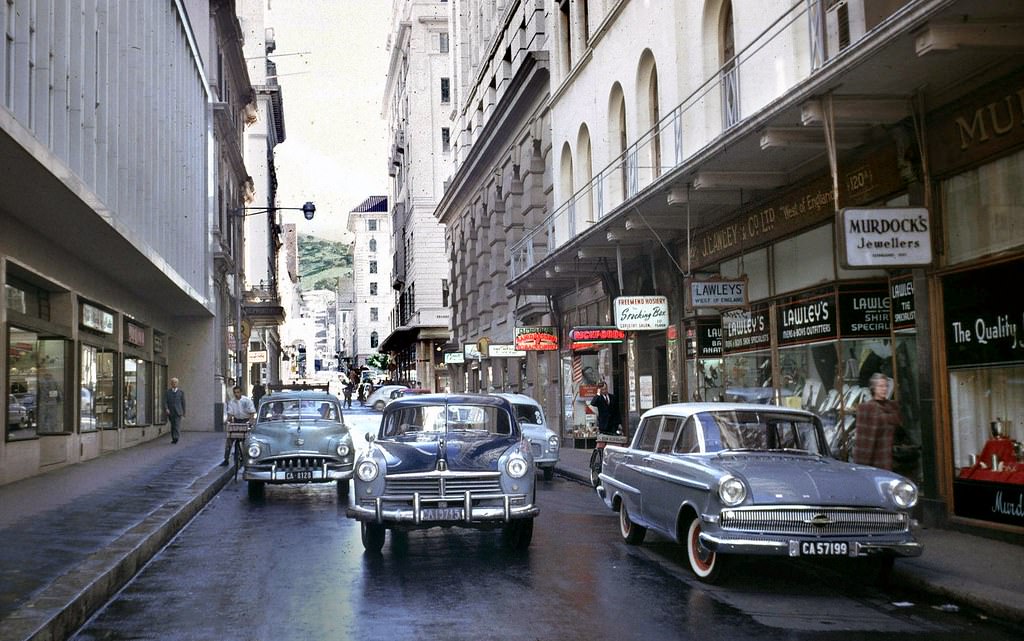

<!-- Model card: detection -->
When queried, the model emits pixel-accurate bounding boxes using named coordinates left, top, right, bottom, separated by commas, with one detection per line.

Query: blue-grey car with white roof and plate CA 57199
left=597, top=402, right=922, bottom=583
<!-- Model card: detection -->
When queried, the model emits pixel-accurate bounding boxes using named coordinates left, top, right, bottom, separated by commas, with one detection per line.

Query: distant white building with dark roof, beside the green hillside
left=348, top=196, right=394, bottom=367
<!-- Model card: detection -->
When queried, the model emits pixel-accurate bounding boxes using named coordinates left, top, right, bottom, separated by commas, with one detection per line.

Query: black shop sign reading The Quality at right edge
left=942, top=261, right=1024, bottom=368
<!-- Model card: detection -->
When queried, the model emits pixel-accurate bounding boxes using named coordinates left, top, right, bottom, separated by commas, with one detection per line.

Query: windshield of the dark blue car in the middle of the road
left=382, top=404, right=512, bottom=437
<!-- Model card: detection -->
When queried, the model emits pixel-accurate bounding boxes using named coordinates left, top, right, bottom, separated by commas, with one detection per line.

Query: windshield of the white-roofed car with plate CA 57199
left=694, top=412, right=827, bottom=454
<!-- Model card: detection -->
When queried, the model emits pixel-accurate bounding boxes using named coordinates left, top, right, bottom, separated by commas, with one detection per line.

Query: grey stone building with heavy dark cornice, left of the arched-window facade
left=436, top=0, right=561, bottom=399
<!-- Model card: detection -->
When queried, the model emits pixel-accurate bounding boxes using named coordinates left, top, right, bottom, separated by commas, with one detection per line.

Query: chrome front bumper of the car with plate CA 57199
left=700, top=531, right=924, bottom=557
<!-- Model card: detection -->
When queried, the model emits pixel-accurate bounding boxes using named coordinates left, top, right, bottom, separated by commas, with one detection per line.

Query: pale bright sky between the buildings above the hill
left=266, top=0, right=391, bottom=241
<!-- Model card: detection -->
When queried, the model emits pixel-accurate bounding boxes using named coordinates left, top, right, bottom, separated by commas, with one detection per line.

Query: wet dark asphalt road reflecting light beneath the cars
left=74, top=412, right=1020, bottom=641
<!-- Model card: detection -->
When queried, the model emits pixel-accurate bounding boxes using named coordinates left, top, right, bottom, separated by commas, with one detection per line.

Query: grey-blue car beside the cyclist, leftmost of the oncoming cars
left=242, top=391, right=355, bottom=500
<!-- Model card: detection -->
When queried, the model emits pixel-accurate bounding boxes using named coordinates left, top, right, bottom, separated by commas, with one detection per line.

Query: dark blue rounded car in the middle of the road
left=347, top=394, right=540, bottom=553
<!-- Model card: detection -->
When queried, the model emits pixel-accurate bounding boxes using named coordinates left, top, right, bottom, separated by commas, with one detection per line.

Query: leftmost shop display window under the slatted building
left=7, top=327, right=69, bottom=440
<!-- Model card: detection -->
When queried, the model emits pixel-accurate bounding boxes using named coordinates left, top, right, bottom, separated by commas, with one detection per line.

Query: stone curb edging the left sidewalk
left=3, top=466, right=233, bottom=641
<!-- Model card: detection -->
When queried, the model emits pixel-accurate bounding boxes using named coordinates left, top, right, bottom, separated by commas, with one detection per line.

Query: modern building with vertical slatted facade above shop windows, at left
left=0, top=0, right=249, bottom=482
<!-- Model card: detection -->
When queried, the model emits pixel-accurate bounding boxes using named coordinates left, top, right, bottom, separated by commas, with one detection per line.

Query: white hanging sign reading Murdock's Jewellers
left=836, top=207, right=932, bottom=268
